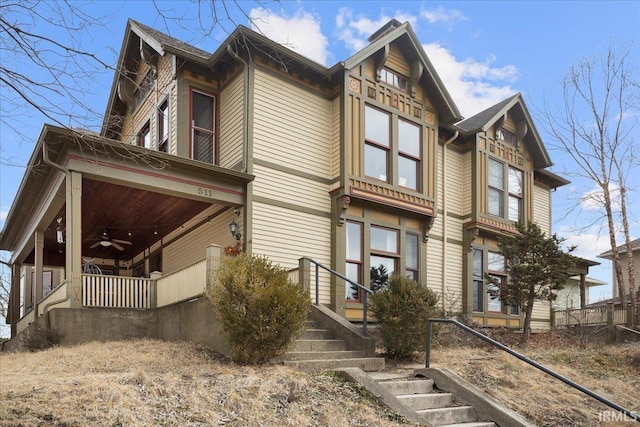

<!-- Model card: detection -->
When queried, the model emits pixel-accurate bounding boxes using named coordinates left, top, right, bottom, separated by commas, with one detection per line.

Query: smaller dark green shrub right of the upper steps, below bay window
left=371, top=275, right=438, bottom=359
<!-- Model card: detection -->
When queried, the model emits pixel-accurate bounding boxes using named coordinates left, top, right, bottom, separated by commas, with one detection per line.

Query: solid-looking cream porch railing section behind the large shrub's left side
left=156, top=260, right=207, bottom=307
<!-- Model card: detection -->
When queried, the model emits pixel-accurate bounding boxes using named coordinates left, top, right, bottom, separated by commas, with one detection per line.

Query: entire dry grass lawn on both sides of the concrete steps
left=0, top=336, right=640, bottom=427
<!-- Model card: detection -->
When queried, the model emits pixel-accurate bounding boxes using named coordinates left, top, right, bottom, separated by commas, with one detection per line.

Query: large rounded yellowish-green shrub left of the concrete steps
left=208, top=253, right=311, bottom=364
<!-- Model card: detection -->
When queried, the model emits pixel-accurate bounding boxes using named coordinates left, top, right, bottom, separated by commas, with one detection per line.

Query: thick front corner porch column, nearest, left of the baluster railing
left=65, top=171, right=82, bottom=308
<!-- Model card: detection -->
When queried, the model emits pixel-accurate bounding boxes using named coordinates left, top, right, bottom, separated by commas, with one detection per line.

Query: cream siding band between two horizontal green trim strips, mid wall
left=253, top=165, right=331, bottom=214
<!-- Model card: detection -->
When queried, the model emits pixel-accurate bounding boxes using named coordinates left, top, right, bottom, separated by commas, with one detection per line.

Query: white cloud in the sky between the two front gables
left=422, top=43, right=518, bottom=117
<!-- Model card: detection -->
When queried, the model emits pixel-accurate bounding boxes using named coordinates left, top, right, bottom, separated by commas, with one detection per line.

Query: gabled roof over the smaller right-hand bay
left=452, top=93, right=553, bottom=170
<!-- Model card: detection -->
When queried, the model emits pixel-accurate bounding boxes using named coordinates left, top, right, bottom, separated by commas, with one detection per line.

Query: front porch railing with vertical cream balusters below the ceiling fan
left=82, top=274, right=154, bottom=308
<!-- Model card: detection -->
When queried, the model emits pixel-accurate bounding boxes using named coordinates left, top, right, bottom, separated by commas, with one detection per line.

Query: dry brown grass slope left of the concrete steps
left=0, top=340, right=418, bottom=427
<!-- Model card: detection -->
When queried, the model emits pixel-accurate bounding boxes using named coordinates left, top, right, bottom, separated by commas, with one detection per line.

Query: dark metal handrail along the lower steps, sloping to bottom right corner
left=425, top=319, right=640, bottom=422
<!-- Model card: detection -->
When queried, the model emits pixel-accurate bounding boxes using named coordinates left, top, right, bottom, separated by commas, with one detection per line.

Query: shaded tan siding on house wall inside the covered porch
left=162, top=210, right=243, bottom=274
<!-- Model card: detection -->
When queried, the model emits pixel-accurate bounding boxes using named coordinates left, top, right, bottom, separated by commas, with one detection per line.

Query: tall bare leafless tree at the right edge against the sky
left=543, top=44, right=640, bottom=324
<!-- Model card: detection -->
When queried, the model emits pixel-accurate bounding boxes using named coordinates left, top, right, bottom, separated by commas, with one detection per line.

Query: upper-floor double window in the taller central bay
left=364, top=105, right=422, bottom=191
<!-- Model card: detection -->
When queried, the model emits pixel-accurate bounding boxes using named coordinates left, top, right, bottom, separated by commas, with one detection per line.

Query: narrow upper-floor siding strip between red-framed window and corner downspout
left=219, top=74, right=245, bottom=168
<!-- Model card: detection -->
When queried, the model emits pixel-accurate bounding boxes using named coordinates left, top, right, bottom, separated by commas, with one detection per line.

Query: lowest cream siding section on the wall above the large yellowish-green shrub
left=252, top=202, right=331, bottom=304
